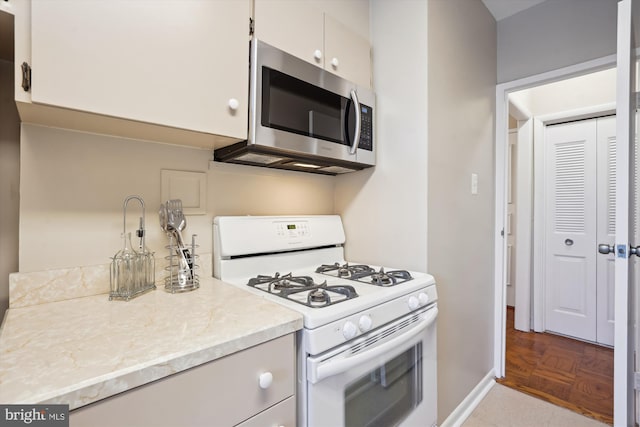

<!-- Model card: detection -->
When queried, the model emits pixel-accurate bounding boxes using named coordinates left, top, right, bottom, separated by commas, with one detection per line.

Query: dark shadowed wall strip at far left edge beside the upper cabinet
left=0, top=58, right=20, bottom=321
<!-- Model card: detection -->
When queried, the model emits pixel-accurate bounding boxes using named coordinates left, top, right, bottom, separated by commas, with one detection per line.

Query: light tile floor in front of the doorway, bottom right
left=462, top=384, right=607, bottom=427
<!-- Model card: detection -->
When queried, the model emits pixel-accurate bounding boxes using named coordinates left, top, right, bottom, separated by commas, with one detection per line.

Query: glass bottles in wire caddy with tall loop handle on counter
left=109, top=196, right=156, bottom=301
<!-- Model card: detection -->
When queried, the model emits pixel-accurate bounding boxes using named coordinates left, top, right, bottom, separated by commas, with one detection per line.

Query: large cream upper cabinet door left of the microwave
left=31, top=0, right=250, bottom=138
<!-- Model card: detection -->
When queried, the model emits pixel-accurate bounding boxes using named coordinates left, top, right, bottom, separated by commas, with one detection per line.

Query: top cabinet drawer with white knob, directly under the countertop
left=70, top=334, right=295, bottom=427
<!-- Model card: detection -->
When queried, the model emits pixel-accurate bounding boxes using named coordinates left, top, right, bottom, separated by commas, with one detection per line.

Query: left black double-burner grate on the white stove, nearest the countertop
left=247, top=273, right=358, bottom=308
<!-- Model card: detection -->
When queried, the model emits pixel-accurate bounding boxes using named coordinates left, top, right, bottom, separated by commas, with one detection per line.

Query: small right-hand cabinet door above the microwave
left=324, top=14, right=371, bottom=87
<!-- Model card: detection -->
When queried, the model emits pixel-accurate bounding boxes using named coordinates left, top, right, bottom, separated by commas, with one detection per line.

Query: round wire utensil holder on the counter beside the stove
left=164, top=234, right=200, bottom=294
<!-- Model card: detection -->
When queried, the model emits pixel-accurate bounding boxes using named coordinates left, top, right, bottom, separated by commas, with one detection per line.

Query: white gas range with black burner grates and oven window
left=213, top=215, right=438, bottom=427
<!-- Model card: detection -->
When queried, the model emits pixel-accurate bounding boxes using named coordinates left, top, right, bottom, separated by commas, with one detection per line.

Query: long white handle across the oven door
left=307, top=307, right=438, bottom=384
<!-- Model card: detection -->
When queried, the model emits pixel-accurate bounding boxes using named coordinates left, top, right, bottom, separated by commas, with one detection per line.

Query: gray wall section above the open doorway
left=498, top=0, right=618, bottom=83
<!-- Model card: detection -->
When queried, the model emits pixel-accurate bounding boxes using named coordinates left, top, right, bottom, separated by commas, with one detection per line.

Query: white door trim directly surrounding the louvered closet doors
left=530, top=102, right=616, bottom=332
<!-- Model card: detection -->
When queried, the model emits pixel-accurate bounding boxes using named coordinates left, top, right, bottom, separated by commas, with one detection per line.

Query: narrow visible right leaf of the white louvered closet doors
left=594, top=116, right=616, bottom=346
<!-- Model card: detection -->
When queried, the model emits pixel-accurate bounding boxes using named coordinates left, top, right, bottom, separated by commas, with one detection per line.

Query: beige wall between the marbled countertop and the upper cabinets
left=20, top=124, right=334, bottom=272
